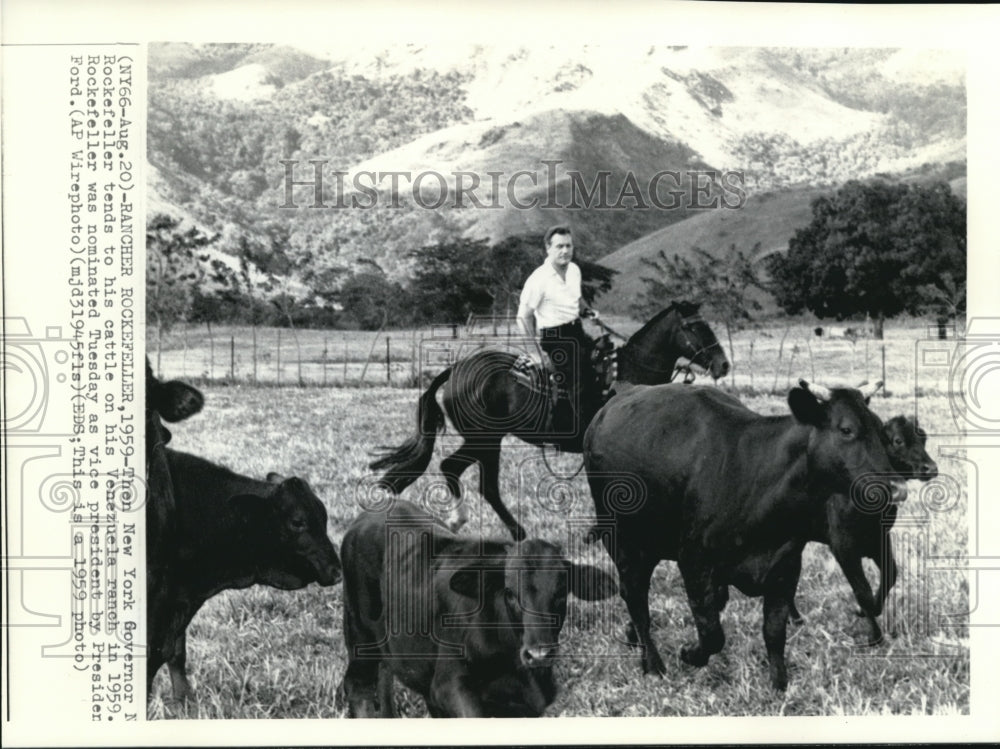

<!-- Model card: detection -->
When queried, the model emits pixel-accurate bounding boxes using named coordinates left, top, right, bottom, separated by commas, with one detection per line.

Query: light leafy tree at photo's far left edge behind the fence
left=146, top=213, right=217, bottom=370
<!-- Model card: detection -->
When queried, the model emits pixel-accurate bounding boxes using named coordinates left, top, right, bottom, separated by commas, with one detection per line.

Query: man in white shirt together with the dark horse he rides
left=369, top=227, right=729, bottom=540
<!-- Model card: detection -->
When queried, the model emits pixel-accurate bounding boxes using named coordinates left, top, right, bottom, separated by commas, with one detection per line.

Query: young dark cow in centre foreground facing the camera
left=338, top=500, right=616, bottom=717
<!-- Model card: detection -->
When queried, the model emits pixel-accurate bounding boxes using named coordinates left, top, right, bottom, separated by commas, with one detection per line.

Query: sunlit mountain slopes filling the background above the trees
left=148, top=44, right=965, bottom=296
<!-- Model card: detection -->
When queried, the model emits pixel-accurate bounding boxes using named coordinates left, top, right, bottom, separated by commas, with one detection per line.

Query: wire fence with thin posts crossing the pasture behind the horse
left=150, top=317, right=962, bottom=394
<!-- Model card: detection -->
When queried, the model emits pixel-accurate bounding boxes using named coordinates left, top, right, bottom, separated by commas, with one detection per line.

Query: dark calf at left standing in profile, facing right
left=146, top=449, right=340, bottom=700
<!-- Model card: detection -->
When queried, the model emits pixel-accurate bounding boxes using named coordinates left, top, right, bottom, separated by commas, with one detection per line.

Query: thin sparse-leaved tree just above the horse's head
left=632, top=242, right=765, bottom=368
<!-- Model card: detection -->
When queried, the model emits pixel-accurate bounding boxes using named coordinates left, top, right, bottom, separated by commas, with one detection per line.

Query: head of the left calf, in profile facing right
left=229, top=473, right=341, bottom=590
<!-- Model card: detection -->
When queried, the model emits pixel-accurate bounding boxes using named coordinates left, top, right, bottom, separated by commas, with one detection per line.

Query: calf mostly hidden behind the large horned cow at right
left=789, top=416, right=938, bottom=645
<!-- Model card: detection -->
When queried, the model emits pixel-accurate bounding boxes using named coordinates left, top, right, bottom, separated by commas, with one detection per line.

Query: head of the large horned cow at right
left=788, top=380, right=906, bottom=502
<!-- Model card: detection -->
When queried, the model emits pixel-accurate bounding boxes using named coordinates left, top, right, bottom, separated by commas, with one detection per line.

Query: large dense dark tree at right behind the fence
left=768, top=181, right=966, bottom=338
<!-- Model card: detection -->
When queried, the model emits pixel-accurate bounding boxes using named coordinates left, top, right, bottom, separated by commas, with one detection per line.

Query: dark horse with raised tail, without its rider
left=369, top=302, right=729, bottom=541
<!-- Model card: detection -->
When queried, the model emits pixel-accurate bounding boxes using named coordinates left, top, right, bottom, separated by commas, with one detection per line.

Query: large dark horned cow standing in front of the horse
left=584, top=383, right=905, bottom=689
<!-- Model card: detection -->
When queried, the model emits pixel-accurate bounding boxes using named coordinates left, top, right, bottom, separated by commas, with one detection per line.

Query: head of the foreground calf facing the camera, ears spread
left=450, top=539, right=618, bottom=667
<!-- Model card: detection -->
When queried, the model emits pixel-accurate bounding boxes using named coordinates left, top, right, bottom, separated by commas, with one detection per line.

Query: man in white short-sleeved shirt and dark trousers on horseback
left=517, top=226, right=598, bottom=440
